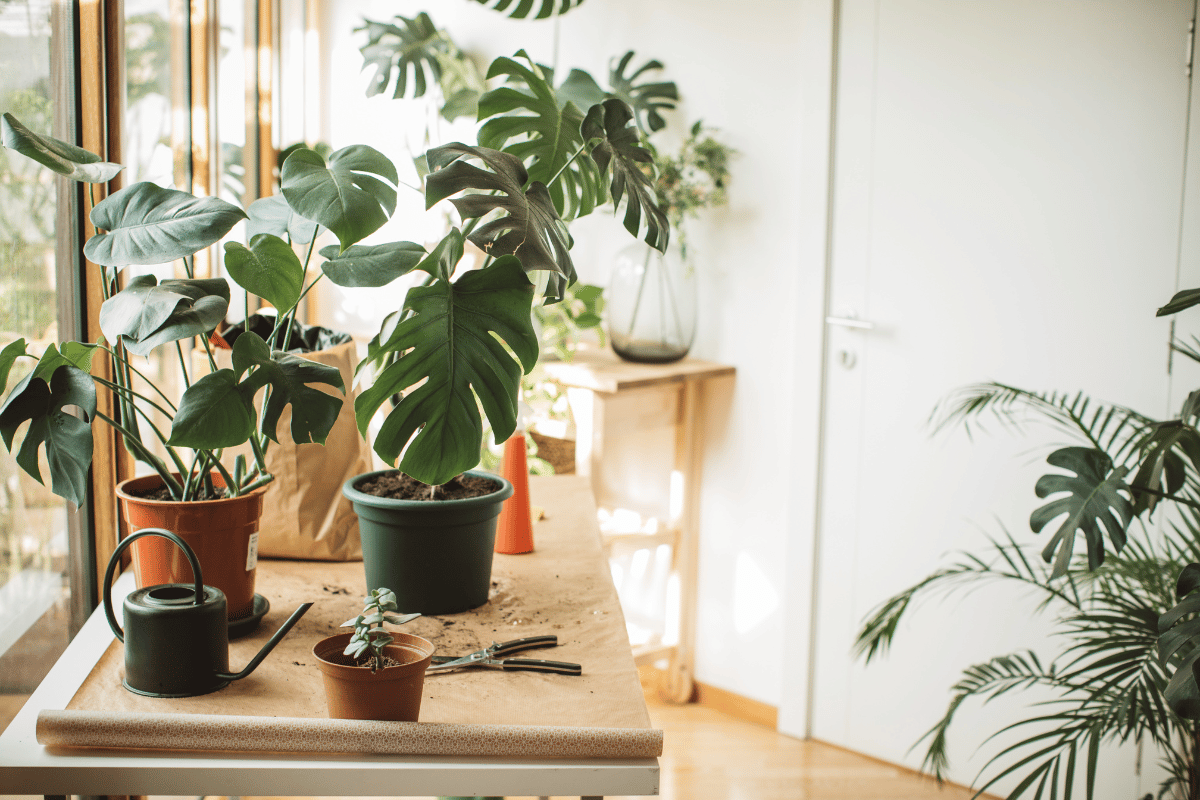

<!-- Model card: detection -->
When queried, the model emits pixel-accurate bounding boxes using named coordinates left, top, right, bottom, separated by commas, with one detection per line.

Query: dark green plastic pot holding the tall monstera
left=342, top=470, right=512, bottom=614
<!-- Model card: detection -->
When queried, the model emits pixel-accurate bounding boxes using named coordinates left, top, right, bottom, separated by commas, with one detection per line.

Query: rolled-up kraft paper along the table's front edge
left=37, top=710, right=662, bottom=758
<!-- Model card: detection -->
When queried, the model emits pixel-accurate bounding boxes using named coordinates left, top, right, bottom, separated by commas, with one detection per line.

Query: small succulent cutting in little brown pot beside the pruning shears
left=312, top=589, right=433, bottom=722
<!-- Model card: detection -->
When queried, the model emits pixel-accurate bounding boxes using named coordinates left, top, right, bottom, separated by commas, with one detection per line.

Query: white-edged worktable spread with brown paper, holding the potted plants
left=0, top=476, right=659, bottom=796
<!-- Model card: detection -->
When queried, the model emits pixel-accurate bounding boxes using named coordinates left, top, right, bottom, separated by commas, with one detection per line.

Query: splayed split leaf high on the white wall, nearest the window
left=356, top=11, right=446, bottom=100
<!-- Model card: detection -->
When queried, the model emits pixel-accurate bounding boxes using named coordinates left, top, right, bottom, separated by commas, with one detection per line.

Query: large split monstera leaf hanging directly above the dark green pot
left=354, top=258, right=538, bottom=483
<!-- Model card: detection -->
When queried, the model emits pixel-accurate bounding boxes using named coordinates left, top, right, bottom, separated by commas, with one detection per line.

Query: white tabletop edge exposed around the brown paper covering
left=0, top=573, right=659, bottom=798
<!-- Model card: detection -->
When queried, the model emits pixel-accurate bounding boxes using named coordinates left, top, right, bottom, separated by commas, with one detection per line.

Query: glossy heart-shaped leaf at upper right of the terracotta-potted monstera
left=281, top=145, right=400, bottom=251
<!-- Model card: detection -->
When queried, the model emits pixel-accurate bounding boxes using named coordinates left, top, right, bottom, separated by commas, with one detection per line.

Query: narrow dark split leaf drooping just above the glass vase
left=582, top=100, right=671, bottom=253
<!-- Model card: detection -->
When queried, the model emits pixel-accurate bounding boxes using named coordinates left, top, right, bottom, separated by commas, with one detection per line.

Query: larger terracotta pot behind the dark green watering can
left=116, top=474, right=268, bottom=619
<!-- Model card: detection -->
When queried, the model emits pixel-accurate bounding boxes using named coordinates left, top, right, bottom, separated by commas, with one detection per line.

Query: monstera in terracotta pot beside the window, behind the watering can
left=0, top=114, right=400, bottom=620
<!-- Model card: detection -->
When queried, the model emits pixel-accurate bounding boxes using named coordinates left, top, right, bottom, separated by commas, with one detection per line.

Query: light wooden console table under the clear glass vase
left=542, top=349, right=736, bottom=703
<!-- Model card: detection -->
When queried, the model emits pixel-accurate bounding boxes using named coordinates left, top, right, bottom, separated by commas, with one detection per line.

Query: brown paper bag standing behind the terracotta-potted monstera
left=201, top=342, right=371, bottom=561
